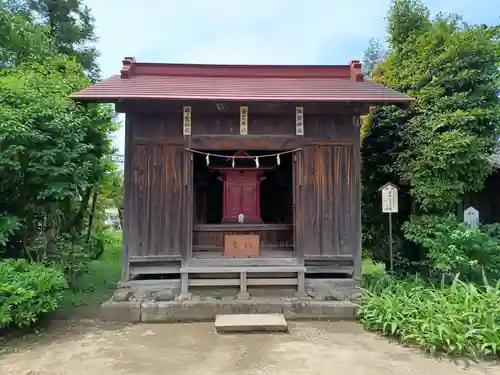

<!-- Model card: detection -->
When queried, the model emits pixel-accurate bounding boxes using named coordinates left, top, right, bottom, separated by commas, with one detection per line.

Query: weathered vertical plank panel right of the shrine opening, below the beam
left=296, top=144, right=359, bottom=258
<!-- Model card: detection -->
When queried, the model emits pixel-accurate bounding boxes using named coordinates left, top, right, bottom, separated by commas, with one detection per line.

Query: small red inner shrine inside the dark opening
left=213, top=151, right=273, bottom=223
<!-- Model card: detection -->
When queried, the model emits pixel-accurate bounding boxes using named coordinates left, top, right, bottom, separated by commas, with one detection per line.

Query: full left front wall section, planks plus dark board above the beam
left=124, top=113, right=191, bottom=260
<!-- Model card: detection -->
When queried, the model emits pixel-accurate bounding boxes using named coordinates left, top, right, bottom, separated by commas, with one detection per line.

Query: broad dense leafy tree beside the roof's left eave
left=0, top=58, right=111, bottom=253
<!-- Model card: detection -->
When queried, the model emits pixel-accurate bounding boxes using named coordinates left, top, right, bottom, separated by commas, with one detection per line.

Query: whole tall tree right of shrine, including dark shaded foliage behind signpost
left=362, top=0, right=500, bottom=268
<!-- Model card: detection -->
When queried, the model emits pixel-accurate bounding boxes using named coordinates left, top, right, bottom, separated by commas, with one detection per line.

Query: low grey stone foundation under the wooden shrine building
left=101, top=279, right=360, bottom=323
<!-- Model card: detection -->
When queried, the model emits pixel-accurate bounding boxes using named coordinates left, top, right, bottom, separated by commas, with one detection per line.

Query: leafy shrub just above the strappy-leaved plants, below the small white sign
left=404, top=216, right=500, bottom=281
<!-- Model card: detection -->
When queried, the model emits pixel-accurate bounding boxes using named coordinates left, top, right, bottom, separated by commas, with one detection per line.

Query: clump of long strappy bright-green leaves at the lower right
left=359, top=277, right=500, bottom=359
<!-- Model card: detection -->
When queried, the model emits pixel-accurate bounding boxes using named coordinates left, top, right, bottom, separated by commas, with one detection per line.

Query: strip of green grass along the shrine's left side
left=57, top=232, right=122, bottom=318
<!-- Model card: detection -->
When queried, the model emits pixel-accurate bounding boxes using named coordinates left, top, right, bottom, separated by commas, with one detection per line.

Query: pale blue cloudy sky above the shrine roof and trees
left=85, top=0, right=500, bottom=154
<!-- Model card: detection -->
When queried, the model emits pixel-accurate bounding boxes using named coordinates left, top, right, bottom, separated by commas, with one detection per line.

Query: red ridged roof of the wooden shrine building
left=71, top=58, right=413, bottom=103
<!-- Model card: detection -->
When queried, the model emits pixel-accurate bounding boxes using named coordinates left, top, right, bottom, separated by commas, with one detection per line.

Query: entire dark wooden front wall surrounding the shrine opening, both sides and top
left=124, top=101, right=361, bottom=278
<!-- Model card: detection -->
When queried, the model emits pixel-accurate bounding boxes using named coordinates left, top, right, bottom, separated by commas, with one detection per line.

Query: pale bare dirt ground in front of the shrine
left=0, top=322, right=500, bottom=375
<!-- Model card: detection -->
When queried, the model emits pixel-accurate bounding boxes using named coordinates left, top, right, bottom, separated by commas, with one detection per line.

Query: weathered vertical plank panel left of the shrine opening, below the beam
left=128, top=144, right=189, bottom=257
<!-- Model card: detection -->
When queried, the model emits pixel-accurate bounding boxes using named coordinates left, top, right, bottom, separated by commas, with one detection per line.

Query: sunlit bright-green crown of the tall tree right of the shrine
left=394, top=16, right=500, bottom=213
